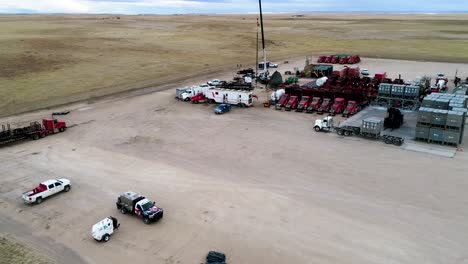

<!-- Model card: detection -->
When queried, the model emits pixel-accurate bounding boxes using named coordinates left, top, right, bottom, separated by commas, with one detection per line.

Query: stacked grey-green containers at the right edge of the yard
left=416, top=90, right=468, bottom=146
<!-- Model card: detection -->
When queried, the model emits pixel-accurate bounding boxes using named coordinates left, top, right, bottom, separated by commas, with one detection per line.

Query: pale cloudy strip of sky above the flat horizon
left=0, top=0, right=468, bottom=14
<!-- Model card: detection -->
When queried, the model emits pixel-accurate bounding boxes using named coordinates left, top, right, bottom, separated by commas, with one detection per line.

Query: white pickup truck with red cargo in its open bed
left=23, top=179, right=71, bottom=204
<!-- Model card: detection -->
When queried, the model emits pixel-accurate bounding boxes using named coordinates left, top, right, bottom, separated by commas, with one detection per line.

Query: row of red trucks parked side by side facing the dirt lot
left=275, top=94, right=361, bottom=117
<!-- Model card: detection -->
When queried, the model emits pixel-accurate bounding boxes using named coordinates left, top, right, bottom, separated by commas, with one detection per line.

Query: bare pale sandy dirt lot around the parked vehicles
left=0, top=56, right=468, bottom=264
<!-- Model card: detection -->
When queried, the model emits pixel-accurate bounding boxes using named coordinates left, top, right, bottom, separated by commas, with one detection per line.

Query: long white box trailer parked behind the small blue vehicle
left=205, top=88, right=253, bottom=107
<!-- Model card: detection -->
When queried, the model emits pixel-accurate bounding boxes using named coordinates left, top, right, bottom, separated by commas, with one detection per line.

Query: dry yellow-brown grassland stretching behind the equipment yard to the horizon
left=0, top=15, right=468, bottom=116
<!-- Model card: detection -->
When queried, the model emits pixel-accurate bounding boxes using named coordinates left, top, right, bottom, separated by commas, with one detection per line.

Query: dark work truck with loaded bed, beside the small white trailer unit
left=115, top=192, right=164, bottom=224
